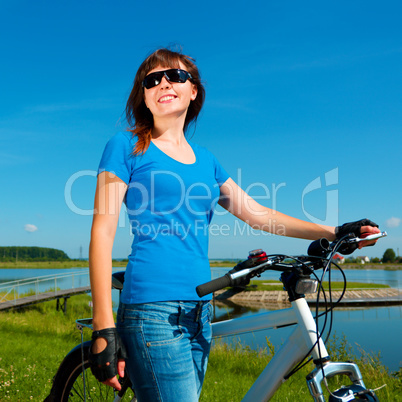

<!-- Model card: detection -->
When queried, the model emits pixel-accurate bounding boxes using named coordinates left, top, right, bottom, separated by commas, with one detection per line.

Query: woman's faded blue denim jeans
left=116, top=301, right=212, bottom=402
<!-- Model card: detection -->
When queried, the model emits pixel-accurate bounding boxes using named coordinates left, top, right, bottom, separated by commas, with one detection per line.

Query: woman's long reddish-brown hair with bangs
left=126, top=48, right=205, bottom=155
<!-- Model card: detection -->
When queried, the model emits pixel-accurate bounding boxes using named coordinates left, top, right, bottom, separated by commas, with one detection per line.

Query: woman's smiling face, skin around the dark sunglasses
left=144, top=62, right=197, bottom=121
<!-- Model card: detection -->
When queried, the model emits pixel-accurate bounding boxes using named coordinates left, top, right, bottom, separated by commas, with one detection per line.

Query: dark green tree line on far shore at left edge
left=0, top=246, right=70, bottom=262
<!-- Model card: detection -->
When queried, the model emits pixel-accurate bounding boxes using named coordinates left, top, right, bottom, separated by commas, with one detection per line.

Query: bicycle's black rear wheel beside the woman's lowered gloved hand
left=44, top=342, right=136, bottom=402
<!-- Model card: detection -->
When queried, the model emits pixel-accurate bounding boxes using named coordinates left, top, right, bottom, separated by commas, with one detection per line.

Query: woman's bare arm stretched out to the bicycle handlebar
left=219, top=178, right=379, bottom=247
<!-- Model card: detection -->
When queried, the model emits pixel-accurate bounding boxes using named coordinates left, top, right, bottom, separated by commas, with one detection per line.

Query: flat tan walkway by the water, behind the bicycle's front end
left=214, top=288, right=402, bottom=307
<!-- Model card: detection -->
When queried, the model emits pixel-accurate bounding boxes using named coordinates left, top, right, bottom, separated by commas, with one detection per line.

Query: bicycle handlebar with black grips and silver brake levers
left=196, top=232, right=387, bottom=297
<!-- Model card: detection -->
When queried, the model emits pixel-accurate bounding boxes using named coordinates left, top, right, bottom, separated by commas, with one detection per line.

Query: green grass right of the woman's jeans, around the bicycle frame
left=200, top=338, right=402, bottom=402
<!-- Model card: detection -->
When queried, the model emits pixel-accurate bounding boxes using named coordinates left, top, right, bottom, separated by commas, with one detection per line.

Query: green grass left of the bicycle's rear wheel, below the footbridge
left=0, top=295, right=92, bottom=401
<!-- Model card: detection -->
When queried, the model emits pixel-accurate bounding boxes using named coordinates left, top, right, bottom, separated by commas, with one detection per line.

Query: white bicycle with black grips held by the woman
left=45, top=232, right=387, bottom=402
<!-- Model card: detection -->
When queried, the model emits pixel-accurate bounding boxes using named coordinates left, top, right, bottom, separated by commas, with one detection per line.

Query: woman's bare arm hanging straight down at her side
left=89, top=172, right=127, bottom=389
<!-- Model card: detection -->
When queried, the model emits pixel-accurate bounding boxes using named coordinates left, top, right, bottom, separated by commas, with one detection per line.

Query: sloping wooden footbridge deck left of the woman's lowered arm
left=0, top=286, right=91, bottom=312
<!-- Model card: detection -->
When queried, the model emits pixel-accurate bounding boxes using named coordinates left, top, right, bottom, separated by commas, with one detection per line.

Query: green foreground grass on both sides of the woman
left=0, top=295, right=402, bottom=402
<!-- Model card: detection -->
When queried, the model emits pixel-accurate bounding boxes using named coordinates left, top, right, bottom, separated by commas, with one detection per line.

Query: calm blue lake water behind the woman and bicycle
left=0, top=268, right=402, bottom=371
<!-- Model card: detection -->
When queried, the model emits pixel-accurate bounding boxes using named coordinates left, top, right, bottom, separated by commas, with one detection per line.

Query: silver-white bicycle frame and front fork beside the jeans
left=212, top=298, right=365, bottom=402
